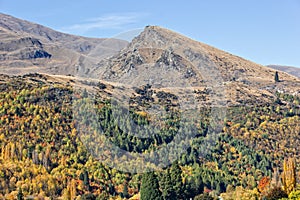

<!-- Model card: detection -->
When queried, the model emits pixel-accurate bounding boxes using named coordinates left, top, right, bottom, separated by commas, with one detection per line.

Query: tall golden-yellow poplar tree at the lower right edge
left=281, top=158, right=296, bottom=194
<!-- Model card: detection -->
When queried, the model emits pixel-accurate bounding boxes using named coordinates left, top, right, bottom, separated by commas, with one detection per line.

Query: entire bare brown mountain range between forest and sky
left=0, top=14, right=300, bottom=104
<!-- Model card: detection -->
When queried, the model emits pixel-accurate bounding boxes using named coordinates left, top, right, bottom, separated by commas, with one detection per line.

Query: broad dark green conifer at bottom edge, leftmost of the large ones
left=141, top=172, right=162, bottom=200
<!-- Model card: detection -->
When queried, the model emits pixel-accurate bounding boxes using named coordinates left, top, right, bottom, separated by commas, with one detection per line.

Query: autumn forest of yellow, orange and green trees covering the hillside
left=0, top=74, right=300, bottom=200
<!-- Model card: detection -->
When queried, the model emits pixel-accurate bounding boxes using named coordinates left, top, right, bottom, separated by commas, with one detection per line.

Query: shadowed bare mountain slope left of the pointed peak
left=0, top=13, right=128, bottom=75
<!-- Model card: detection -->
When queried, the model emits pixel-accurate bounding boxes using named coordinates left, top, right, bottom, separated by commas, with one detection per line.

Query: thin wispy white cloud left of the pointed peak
left=61, top=13, right=145, bottom=33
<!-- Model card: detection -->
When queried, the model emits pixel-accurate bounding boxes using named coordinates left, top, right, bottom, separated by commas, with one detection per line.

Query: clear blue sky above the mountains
left=0, top=0, right=300, bottom=67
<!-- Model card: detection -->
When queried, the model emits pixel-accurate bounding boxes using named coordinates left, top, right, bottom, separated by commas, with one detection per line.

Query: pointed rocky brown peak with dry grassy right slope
left=93, top=26, right=300, bottom=104
